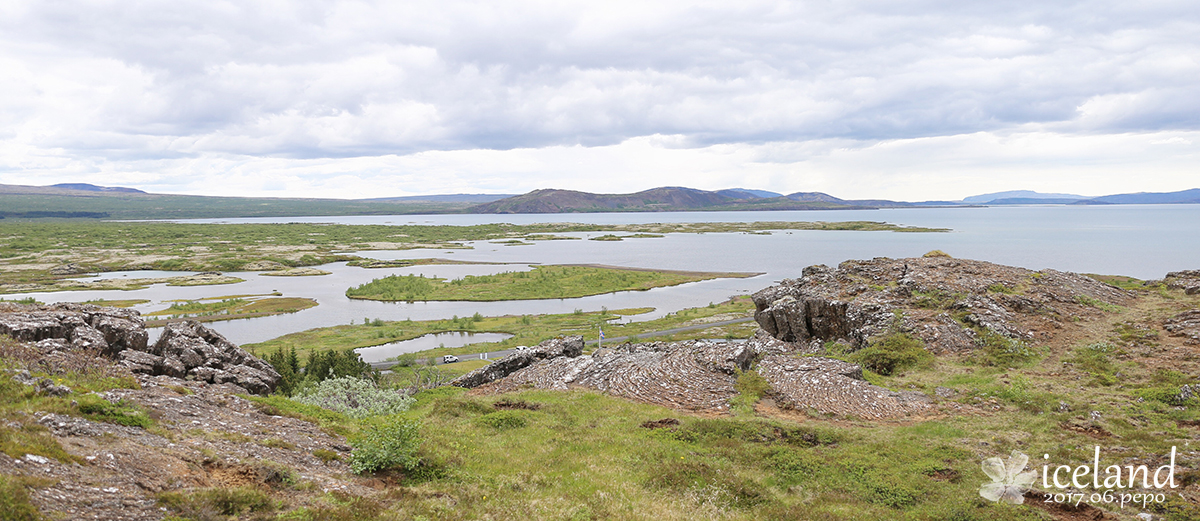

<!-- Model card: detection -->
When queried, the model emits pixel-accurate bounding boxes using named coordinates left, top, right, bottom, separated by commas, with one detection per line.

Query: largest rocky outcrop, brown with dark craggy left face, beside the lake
left=754, top=257, right=1132, bottom=353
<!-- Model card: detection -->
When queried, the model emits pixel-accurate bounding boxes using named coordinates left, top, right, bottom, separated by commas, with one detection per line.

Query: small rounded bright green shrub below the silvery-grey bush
left=350, top=417, right=420, bottom=474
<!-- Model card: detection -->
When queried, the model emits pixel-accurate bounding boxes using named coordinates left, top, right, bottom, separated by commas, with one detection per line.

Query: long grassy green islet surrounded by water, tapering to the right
left=346, top=265, right=748, bottom=301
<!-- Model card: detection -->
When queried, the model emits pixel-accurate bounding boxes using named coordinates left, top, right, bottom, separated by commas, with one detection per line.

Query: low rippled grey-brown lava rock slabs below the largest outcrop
left=456, top=335, right=930, bottom=419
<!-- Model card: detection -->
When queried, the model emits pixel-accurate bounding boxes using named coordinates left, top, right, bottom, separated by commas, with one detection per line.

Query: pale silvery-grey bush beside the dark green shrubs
left=292, top=376, right=413, bottom=419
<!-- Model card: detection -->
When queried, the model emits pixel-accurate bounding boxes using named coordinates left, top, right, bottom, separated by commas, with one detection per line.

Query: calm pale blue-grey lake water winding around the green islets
left=11, top=204, right=1200, bottom=343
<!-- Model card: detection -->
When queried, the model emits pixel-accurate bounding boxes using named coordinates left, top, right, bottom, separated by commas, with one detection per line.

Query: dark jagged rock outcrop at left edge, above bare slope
left=0, top=304, right=280, bottom=395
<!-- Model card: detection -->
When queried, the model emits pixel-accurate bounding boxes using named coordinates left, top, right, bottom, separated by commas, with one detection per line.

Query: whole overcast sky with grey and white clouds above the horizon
left=0, top=0, right=1200, bottom=200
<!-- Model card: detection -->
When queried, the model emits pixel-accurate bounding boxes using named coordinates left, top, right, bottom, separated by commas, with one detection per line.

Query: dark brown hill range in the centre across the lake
left=466, top=186, right=857, bottom=214
